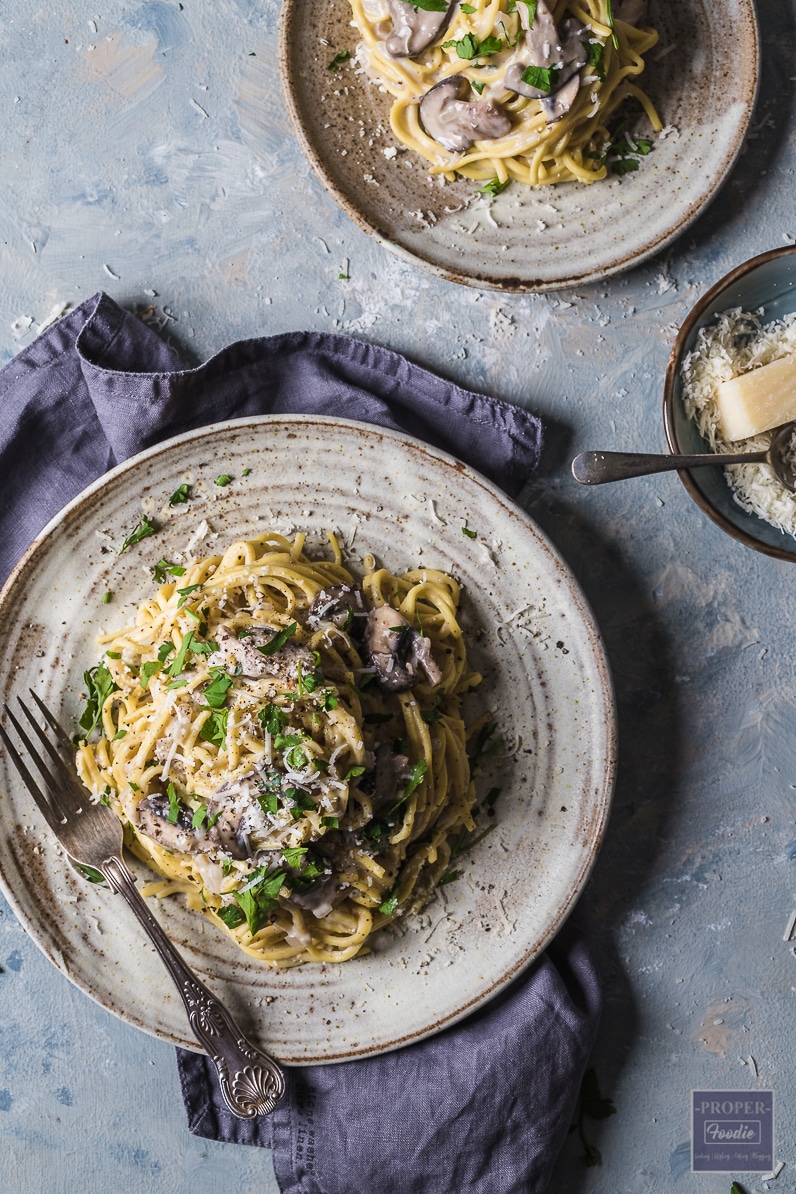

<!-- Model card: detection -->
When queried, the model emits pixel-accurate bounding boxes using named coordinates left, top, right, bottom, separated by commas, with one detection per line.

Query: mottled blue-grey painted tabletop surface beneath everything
left=0, top=0, right=796, bottom=1194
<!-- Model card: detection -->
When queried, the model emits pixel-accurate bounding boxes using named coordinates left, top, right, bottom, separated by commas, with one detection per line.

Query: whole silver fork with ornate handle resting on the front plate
left=0, top=689, right=285, bottom=1119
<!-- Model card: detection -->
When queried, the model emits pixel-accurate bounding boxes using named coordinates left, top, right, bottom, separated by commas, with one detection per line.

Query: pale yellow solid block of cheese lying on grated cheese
left=716, top=353, right=796, bottom=439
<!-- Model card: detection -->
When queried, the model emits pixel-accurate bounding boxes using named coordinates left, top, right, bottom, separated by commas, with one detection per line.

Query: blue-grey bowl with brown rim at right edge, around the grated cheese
left=664, top=246, right=796, bottom=561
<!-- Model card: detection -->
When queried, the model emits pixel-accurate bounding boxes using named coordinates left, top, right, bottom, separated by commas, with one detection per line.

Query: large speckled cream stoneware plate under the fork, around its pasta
left=0, top=417, right=615, bottom=1064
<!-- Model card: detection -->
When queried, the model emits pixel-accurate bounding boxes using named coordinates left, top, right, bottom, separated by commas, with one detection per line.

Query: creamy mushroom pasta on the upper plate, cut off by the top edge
left=351, top=0, right=661, bottom=186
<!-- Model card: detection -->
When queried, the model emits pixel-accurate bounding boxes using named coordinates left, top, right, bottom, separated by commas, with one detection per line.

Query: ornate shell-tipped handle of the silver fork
left=99, top=856, right=285, bottom=1119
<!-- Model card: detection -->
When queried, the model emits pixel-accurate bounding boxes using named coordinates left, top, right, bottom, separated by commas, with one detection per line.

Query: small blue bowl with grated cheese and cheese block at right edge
left=664, top=246, right=796, bottom=561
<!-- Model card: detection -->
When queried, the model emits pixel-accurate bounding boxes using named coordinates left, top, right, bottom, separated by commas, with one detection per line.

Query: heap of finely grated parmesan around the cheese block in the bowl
left=681, top=307, right=796, bottom=537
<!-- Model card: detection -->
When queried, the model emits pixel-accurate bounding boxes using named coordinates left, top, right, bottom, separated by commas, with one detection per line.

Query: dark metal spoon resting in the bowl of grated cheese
left=572, top=423, right=796, bottom=491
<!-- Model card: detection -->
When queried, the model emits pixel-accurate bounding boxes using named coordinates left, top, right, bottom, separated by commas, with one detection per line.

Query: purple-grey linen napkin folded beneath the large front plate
left=0, top=294, right=600, bottom=1194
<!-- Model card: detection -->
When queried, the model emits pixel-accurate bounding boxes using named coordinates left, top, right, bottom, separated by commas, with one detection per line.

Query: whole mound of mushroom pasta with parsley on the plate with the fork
left=78, top=534, right=481, bottom=966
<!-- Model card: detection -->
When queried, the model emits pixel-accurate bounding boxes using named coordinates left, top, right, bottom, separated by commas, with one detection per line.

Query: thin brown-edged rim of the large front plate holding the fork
left=0, top=414, right=618, bottom=1066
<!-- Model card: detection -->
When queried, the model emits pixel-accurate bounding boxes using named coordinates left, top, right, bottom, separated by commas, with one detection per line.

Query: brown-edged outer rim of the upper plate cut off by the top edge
left=278, top=0, right=763, bottom=294
